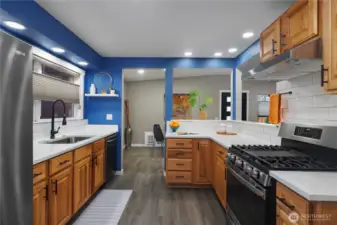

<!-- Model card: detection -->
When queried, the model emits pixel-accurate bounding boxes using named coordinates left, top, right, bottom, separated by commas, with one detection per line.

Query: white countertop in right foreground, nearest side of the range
left=269, top=171, right=337, bottom=202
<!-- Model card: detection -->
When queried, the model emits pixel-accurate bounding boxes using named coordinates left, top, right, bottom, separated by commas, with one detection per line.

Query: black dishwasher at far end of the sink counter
left=105, top=133, right=117, bottom=182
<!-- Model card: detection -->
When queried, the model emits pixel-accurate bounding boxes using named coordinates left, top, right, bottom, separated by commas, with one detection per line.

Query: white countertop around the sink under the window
left=33, top=125, right=118, bottom=165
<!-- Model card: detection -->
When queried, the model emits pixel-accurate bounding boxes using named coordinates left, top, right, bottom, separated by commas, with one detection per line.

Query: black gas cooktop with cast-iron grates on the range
left=232, top=145, right=337, bottom=171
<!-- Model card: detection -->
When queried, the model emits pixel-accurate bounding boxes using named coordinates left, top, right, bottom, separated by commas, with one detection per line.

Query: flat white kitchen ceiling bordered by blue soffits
left=36, top=0, right=294, bottom=57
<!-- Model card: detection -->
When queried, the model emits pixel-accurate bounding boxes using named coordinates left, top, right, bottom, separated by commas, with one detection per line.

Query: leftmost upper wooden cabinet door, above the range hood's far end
left=260, top=19, right=281, bottom=62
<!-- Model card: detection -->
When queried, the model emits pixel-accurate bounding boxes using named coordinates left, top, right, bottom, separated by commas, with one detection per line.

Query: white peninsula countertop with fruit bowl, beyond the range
left=166, top=131, right=268, bottom=148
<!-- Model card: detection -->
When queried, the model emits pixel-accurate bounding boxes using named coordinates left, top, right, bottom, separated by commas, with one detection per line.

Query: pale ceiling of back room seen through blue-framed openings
left=123, top=69, right=232, bottom=82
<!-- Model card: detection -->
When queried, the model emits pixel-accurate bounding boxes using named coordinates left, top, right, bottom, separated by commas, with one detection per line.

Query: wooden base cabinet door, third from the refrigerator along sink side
left=74, top=157, right=92, bottom=213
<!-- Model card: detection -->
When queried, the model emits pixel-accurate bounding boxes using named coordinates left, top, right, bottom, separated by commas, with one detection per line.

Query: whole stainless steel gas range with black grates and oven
left=226, top=123, right=337, bottom=225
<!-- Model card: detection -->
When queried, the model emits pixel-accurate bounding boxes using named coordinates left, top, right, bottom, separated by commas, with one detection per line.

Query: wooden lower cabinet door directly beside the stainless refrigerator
left=33, top=181, right=48, bottom=225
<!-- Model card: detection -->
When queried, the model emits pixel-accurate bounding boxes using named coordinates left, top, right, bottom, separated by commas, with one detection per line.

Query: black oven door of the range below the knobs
left=227, top=168, right=270, bottom=225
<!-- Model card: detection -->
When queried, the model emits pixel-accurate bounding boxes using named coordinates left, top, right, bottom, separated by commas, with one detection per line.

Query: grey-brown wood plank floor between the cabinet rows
left=105, top=148, right=225, bottom=225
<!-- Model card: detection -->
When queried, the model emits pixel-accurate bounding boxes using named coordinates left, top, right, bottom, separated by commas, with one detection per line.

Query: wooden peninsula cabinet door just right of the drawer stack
left=192, top=140, right=212, bottom=184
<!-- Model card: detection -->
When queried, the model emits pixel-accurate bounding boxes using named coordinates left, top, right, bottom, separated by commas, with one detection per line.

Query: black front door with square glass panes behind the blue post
left=219, top=90, right=249, bottom=121
